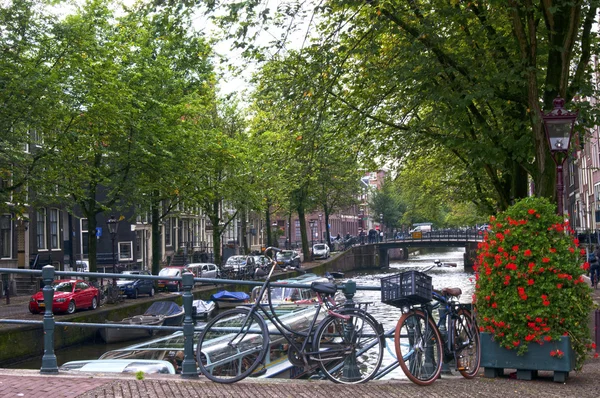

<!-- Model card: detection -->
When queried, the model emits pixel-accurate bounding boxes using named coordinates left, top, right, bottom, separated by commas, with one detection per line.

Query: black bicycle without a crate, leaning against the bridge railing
left=196, top=247, right=384, bottom=384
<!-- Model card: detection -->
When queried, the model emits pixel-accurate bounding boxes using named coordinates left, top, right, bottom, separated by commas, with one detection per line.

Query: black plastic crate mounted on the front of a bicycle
left=381, top=271, right=432, bottom=307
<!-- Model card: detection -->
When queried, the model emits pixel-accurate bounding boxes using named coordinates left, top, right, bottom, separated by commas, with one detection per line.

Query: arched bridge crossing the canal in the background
left=374, top=231, right=483, bottom=268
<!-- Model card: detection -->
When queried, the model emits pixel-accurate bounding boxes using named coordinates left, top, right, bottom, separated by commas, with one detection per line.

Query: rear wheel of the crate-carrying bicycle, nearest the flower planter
left=453, top=308, right=481, bottom=379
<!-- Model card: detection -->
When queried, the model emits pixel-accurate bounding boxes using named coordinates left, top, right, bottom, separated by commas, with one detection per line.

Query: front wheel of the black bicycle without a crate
left=196, top=308, right=269, bottom=383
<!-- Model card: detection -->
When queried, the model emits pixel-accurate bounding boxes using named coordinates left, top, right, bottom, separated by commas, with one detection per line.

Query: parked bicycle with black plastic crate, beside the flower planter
left=381, top=271, right=481, bottom=386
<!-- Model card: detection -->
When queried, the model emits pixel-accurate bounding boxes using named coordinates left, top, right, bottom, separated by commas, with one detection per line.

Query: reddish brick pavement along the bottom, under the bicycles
left=0, top=366, right=600, bottom=398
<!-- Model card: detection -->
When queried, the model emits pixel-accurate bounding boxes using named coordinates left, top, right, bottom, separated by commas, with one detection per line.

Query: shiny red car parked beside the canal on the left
left=29, top=279, right=98, bottom=314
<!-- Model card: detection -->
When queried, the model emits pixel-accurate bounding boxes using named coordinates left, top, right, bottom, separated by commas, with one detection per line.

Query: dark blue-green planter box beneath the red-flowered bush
left=480, top=333, right=575, bottom=383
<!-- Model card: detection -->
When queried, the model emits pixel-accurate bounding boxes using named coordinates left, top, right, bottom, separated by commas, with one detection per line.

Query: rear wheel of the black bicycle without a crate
left=311, top=308, right=385, bottom=384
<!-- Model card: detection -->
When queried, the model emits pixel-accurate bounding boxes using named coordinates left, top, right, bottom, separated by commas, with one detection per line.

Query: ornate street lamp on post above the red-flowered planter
left=542, top=96, right=579, bottom=216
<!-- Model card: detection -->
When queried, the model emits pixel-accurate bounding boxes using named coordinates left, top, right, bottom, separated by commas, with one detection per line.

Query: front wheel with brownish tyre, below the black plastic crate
left=394, top=311, right=443, bottom=386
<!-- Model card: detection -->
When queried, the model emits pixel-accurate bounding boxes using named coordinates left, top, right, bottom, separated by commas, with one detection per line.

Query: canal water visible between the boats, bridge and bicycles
left=7, top=248, right=475, bottom=378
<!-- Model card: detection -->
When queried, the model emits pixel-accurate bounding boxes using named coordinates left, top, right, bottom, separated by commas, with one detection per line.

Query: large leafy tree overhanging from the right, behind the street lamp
left=203, top=0, right=598, bottom=209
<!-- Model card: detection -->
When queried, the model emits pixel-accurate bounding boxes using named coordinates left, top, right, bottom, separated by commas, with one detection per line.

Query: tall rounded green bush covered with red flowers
left=473, top=197, right=592, bottom=369
